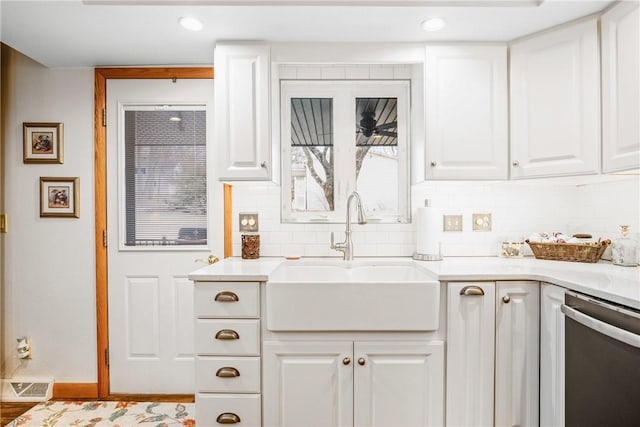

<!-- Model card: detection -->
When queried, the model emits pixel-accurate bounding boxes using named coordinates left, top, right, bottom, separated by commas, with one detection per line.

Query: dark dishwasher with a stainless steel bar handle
left=561, top=292, right=640, bottom=427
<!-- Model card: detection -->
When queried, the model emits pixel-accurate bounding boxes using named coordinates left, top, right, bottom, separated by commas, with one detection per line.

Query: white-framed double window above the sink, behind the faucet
left=280, top=80, right=410, bottom=223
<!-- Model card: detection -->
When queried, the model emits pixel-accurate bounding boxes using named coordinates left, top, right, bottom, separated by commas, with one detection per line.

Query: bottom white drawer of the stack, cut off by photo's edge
left=196, top=393, right=262, bottom=427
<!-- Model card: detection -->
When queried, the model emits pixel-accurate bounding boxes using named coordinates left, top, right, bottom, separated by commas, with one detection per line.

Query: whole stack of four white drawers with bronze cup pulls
left=194, top=282, right=261, bottom=427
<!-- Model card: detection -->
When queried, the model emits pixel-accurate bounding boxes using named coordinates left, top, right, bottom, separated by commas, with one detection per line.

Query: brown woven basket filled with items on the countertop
left=525, top=233, right=611, bottom=262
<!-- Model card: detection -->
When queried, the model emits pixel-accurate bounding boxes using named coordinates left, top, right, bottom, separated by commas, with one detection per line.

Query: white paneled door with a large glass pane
left=106, top=79, right=215, bottom=394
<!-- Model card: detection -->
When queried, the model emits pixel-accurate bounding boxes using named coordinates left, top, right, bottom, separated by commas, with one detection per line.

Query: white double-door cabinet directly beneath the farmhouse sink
left=263, top=341, right=444, bottom=427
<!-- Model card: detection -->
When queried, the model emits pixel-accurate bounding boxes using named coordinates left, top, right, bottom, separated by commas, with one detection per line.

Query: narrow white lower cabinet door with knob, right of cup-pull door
left=495, top=282, right=540, bottom=427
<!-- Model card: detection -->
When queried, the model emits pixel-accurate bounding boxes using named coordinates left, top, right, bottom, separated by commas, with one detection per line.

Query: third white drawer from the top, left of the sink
left=196, top=356, right=260, bottom=393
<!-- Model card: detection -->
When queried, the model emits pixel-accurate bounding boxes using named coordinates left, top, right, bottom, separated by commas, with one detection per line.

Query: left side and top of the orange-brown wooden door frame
left=94, top=67, right=213, bottom=401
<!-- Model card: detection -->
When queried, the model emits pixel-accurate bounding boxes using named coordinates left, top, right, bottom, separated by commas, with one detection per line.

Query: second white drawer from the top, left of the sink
left=194, top=319, right=260, bottom=356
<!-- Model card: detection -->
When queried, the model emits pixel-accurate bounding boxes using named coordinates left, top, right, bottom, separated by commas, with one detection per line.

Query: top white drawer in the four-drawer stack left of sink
left=194, top=282, right=260, bottom=317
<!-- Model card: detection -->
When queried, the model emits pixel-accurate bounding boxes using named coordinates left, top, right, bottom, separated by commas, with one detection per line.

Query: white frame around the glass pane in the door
left=117, top=102, right=212, bottom=252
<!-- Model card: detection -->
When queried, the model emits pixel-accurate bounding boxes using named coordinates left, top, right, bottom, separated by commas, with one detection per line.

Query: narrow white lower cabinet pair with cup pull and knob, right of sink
left=446, top=282, right=540, bottom=426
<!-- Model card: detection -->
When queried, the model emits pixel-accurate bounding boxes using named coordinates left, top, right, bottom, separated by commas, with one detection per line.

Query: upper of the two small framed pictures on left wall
left=22, top=123, right=63, bottom=163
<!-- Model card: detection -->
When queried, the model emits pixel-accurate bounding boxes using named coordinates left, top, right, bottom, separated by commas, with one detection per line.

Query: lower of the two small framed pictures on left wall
left=40, top=177, right=80, bottom=218
